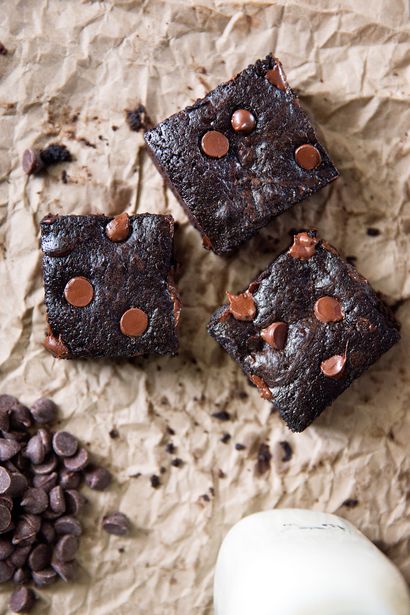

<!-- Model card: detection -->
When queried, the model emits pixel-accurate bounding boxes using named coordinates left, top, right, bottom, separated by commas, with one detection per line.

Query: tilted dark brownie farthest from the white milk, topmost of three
left=145, top=55, right=338, bottom=255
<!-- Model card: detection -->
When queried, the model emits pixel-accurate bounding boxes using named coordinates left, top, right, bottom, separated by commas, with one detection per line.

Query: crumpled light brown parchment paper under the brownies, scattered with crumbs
left=0, top=0, right=410, bottom=615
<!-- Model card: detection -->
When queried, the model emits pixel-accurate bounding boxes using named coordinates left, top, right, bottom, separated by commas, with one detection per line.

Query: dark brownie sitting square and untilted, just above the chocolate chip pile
left=41, top=213, right=180, bottom=359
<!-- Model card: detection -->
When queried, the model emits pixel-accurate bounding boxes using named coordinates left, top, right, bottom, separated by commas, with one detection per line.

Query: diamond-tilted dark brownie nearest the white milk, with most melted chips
left=208, top=231, right=400, bottom=431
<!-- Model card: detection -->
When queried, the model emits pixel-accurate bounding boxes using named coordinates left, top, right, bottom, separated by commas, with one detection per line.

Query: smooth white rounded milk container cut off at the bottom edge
left=214, top=509, right=410, bottom=615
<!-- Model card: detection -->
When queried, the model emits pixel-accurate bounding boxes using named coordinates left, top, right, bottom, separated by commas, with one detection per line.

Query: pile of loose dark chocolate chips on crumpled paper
left=0, top=395, right=113, bottom=613
